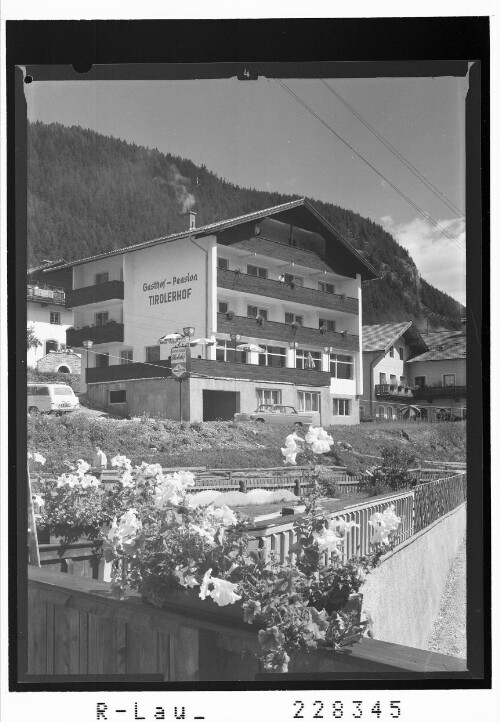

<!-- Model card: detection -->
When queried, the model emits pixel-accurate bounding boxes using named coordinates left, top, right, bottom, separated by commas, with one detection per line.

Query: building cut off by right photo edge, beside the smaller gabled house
left=407, top=324, right=467, bottom=421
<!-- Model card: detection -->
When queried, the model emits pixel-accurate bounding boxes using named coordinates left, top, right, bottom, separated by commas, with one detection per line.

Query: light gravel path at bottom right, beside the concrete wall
left=427, top=539, right=467, bottom=659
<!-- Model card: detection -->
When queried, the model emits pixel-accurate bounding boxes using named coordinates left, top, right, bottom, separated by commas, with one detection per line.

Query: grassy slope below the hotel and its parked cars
left=28, top=411, right=465, bottom=473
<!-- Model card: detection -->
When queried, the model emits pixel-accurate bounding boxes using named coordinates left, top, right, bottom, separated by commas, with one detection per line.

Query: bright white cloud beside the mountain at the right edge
left=380, top=215, right=466, bottom=305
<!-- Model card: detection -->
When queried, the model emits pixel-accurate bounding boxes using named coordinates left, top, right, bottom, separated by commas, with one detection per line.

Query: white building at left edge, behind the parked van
left=27, top=280, right=73, bottom=370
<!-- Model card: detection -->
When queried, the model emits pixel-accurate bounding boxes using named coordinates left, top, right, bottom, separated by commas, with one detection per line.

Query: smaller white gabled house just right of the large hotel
left=360, top=321, right=428, bottom=421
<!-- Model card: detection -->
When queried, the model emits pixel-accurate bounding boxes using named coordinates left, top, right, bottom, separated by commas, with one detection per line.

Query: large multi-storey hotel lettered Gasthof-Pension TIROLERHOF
left=37, top=200, right=377, bottom=425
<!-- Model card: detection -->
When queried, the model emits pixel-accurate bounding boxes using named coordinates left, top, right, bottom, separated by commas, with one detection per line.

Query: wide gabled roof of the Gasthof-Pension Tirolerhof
left=38, top=198, right=378, bottom=280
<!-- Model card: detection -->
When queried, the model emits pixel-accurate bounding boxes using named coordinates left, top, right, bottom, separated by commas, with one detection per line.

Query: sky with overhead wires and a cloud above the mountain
left=25, top=70, right=467, bottom=304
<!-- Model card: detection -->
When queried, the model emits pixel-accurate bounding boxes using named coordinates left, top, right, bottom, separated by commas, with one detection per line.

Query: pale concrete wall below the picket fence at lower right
left=361, top=504, right=466, bottom=649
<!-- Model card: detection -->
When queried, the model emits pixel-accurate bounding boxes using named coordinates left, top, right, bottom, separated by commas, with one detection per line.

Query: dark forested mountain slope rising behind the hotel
left=28, top=122, right=464, bottom=328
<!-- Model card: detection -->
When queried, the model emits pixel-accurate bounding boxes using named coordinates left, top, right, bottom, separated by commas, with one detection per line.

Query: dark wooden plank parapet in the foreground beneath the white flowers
left=23, top=567, right=466, bottom=682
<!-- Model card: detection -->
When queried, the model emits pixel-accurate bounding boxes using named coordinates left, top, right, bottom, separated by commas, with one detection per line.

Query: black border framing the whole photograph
left=6, top=17, right=491, bottom=692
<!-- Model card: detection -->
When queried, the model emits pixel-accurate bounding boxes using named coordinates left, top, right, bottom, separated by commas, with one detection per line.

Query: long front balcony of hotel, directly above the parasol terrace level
left=217, top=313, right=359, bottom=351
